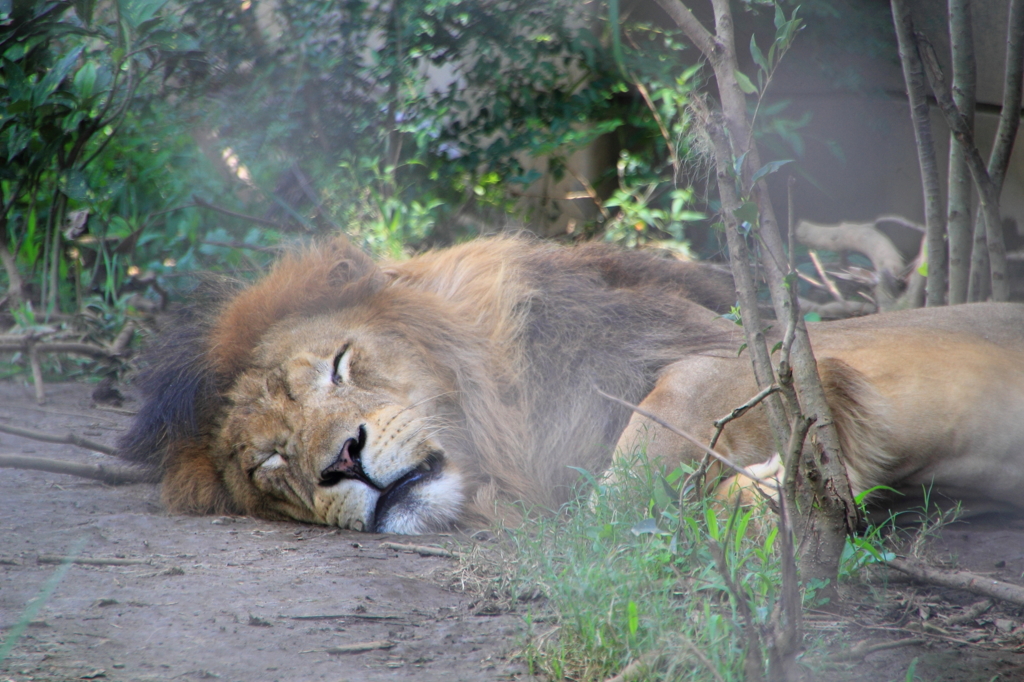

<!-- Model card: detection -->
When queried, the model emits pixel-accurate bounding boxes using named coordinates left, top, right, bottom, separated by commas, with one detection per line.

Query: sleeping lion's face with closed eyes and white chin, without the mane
left=212, top=308, right=467, bottom=534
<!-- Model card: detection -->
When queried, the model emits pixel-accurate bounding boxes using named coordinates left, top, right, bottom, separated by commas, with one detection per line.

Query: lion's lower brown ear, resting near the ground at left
left=163, top=441, right=240, bottom=514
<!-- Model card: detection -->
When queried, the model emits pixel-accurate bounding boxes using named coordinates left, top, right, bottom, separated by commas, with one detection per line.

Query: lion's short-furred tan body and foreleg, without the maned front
left=617, top=304, right=1024, bottom=513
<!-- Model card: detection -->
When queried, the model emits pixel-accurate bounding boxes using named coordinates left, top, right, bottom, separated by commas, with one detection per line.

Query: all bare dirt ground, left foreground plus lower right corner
left=6, top=382, right=1024, bottom=682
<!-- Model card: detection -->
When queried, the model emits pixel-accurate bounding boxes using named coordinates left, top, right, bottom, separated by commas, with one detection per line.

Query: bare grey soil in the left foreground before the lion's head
left=0, top=383, right=524, bottom=682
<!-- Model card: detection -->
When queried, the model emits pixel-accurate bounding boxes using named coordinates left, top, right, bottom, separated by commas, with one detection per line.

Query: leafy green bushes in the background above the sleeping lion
left=0, top=0, right=827, bottom=387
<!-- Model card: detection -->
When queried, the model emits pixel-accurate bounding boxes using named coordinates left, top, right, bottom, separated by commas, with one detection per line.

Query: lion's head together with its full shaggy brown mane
left=122, top=233, right=731, bottom=534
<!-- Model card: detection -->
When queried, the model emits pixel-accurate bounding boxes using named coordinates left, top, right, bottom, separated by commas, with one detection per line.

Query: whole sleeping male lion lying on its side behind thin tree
left=120, top=237, right=1024, bottom=534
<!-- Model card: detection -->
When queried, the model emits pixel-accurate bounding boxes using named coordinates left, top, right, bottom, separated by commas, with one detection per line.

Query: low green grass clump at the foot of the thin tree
left=507, top=446, right=780, bottom=680
